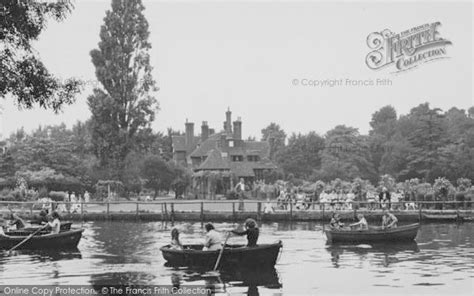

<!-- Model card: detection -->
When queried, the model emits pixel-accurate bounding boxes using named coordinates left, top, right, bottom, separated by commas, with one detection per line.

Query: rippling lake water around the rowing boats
left=0, top=222, right=474, bottom=295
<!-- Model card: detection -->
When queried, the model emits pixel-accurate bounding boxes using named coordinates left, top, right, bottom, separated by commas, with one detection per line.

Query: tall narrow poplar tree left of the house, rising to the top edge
left=88, top=0, right=158, bottom=178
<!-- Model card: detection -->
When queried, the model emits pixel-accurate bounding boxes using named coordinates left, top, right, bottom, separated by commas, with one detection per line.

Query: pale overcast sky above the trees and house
left=0, top=0, right=474, bottom=137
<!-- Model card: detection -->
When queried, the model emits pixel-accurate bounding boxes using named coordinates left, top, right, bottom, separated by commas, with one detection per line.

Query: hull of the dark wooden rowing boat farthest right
left=325, top=223, right=420, bottom=243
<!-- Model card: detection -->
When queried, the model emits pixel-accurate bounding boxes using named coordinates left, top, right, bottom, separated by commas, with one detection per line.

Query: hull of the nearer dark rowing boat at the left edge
left=0, top=229, right=84, bottom=249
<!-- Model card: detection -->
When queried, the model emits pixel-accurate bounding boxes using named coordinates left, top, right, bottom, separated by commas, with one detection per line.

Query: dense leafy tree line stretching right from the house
left=262, top=103, right=474, bottom=184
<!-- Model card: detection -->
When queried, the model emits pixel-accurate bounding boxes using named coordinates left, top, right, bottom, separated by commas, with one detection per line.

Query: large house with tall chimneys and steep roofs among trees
left=172, top=110, right=276, bottom=181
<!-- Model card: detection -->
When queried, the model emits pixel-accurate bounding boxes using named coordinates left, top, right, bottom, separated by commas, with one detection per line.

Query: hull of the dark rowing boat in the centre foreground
left=160, top=241, right=283, bottom=269
